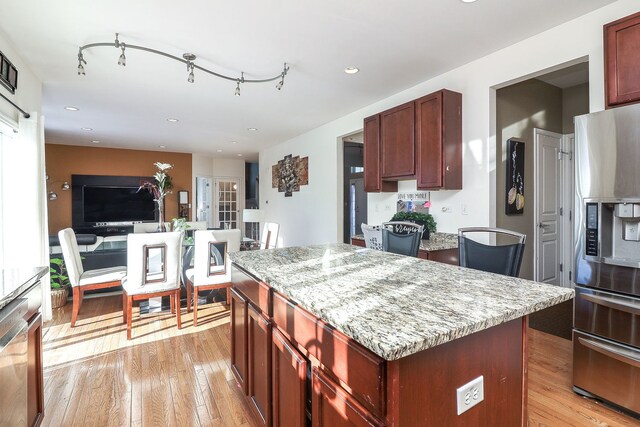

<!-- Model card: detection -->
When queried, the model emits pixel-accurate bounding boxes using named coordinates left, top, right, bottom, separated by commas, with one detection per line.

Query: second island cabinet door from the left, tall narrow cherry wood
left=247, top=304, right=272, bottom=426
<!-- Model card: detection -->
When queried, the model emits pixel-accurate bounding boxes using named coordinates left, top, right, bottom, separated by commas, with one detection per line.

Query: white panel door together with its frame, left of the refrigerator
left=533, top=128, right=574, bottom=287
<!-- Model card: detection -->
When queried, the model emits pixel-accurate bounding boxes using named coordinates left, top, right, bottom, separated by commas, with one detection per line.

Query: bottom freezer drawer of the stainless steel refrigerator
left=573, top=331, right=640, bottom=413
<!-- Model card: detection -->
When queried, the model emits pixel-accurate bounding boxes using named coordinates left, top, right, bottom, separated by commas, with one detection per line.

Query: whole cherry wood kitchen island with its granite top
left=231, top=244, right=573, bottom=426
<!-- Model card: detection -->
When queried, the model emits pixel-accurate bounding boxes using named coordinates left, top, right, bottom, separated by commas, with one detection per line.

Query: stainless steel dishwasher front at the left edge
left=0, top=299, right=28, bottom=426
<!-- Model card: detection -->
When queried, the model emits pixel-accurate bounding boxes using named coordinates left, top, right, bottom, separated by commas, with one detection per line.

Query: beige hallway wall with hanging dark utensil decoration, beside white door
left=496, top=79, right=562, bottom=279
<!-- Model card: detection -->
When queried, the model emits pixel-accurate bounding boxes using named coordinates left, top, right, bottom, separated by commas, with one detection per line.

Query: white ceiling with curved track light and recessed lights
left=0, top=0, right=613, bottom=160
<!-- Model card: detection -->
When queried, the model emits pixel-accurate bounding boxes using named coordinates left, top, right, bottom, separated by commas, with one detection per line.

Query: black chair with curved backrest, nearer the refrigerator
left=458, top=227, right=527, bottom=277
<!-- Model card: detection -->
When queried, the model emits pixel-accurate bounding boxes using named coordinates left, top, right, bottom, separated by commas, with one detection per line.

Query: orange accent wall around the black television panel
left=45, top=144, right=193, bottom=234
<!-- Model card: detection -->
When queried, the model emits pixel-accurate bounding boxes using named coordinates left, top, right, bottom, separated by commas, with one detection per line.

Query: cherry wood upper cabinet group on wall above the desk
left=364, top=89, right=462, bottom=192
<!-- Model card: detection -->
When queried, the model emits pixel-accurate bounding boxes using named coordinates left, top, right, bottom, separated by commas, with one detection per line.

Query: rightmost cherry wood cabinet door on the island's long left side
left=311, top=368, right=383, bottom=427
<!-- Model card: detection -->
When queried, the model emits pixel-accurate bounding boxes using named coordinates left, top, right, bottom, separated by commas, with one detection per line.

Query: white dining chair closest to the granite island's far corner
left=186, top=229, right=242, bottom=326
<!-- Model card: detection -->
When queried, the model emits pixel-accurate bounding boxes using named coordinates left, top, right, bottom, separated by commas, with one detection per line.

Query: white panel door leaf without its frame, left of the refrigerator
left=534, top=129, right=563, bottom=285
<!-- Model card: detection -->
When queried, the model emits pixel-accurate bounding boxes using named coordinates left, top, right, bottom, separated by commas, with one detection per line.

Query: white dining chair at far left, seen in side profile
left=58, top=228, right=127, bottom=327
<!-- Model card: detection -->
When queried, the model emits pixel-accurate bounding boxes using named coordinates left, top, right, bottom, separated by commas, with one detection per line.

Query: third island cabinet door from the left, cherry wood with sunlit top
left=272, top=328, right=308, bottom=427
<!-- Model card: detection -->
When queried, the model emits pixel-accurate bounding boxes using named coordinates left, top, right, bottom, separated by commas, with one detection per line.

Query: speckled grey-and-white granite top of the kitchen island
left=229, top=243, right=574, bottom=360
